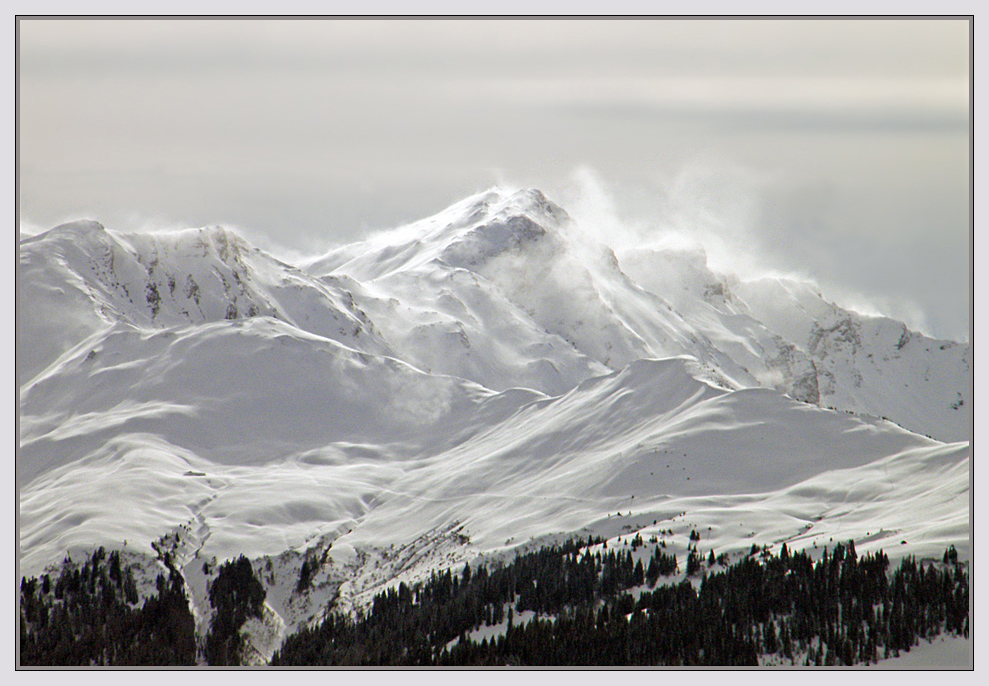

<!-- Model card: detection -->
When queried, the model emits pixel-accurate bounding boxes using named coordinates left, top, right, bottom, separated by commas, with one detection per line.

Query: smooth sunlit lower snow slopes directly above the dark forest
left=21, top=352, right=969, bottom=636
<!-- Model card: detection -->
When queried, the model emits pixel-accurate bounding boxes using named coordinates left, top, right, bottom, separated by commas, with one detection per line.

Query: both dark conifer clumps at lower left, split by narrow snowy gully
left=20, top=548, right=266, bottom=666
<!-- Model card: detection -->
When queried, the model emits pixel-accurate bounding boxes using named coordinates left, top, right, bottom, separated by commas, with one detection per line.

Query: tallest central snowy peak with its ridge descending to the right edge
left=306, top=190, right=971, bottom=440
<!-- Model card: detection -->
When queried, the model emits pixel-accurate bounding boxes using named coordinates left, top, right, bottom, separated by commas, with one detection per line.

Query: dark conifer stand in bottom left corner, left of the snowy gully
left=20, top=547, right=196, bottom=666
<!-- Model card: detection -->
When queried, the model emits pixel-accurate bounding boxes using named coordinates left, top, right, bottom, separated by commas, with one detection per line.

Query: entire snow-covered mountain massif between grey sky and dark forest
left=17, top=189, right=971, bottom=668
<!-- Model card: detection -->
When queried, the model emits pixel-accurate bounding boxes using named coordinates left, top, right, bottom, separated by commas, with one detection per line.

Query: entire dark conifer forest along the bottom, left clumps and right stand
left=20, top=537, right=969, bottom=666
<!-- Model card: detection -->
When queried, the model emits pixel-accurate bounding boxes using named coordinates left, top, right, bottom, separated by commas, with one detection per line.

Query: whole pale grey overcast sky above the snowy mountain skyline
left=18, top=19, right=970, bottom=340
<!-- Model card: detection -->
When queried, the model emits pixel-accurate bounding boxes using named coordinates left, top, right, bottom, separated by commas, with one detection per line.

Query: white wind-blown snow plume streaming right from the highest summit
left=561, top=163, right=944, bottom=340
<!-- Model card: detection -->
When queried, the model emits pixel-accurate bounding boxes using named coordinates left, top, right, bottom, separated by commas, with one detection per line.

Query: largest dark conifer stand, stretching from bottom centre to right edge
left=272, top=540, right=969, bottom=666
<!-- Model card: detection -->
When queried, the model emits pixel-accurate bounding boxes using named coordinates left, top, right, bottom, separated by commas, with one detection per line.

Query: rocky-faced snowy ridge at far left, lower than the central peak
left=17, top=221, right=389, bottom=386
